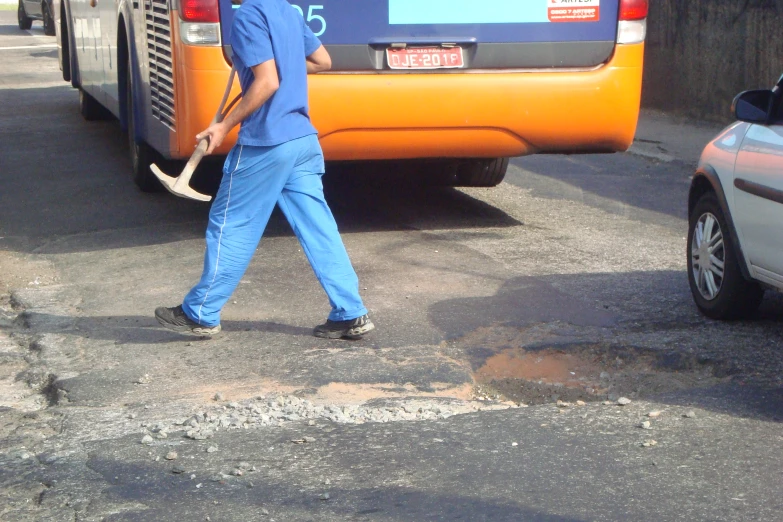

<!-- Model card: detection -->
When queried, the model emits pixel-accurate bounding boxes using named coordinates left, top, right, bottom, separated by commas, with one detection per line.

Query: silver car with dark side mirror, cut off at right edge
left=688, top=73, right=783, bottom=319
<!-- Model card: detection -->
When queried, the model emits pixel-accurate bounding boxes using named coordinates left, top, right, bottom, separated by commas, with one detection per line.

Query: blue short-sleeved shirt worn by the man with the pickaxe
left=231, top=0, right=321, bottom=147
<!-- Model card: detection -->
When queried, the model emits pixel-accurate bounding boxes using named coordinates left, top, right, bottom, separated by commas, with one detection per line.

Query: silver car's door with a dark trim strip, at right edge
left=732, top=102, right=783, bottom=285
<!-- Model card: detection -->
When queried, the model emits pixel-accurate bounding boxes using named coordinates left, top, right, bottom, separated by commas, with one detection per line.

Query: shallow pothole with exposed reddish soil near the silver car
left=468, top=344, right=732, bottom=404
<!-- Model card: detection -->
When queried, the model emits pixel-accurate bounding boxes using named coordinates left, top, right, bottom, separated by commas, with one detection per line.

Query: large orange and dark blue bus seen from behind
left=54, top=0, right=648, bottom=191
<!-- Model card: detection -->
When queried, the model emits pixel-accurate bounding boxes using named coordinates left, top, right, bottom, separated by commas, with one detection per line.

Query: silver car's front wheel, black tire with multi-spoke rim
left=688, top=192, right=764, bottom=319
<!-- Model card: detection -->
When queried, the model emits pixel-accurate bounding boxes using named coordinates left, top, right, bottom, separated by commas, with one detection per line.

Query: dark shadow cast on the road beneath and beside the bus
left=0, top=84, right=521, bottom=254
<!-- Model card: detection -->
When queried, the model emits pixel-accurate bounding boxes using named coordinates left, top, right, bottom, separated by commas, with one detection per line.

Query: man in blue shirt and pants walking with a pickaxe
left=155, top=0, right=375, bottom=339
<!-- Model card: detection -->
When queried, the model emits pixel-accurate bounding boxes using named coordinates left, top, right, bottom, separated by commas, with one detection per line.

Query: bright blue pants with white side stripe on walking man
left=182, top=135, right=367, bottom=326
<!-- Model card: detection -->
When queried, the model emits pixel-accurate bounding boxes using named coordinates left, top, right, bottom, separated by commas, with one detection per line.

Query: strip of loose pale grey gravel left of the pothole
left=142, top=395, right=512, bottom=443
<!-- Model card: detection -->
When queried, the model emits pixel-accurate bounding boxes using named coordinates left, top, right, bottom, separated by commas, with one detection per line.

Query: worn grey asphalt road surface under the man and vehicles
left=0, top=11, right=783, bottom=521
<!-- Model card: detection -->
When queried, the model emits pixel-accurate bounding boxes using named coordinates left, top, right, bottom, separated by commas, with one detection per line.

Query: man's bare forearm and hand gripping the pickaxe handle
left=196, top=58, right=282, bottom=154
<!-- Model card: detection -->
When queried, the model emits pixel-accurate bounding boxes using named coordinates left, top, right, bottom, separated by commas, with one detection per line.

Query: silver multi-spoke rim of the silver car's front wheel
left=691, top=212, right=726, bottom=301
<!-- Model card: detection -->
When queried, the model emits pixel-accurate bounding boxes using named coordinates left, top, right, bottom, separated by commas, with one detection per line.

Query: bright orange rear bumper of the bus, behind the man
left=177, top=44, right=644, bottom=160
